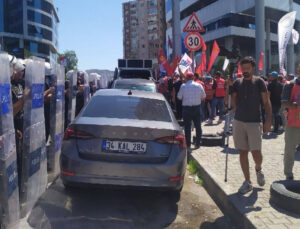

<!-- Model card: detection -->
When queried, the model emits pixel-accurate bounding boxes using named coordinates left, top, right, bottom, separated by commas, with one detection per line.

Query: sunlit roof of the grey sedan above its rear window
left=94, top=89, right=165, bottom=100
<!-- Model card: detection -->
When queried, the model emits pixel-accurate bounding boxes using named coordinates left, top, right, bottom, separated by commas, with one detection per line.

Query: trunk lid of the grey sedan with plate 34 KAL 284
left=71, top=118, right=178, bottom=163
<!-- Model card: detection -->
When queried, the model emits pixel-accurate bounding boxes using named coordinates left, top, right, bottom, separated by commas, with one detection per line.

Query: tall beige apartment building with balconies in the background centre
left=123, top=0, right=166, bottom=64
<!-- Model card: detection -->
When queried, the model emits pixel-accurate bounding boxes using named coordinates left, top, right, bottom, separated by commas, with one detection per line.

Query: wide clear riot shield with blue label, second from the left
left=20, top=58, right=47, bottom=217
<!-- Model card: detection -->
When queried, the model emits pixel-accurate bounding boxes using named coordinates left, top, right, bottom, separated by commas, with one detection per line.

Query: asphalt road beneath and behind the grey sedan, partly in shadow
left=27, top=174, right=234, bottom=229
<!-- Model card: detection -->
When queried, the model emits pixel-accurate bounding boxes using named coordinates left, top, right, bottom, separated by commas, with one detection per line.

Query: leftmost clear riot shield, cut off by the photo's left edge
left=0, top=53, right=20, bottom=228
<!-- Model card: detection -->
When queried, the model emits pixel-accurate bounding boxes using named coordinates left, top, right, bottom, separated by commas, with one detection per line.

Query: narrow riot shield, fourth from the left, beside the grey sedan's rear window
left=65, top=70, right=77, bottom=125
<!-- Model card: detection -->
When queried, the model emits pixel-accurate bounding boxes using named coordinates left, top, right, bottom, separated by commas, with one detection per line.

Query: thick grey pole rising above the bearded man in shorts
left=255, top=0, right=266, bottom=75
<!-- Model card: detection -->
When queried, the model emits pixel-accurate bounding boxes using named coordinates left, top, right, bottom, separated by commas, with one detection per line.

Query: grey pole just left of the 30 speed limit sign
left=172, top=0, right=182, bottom=57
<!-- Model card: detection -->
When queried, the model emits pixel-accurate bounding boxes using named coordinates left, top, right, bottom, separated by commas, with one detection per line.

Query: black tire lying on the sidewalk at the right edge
left=270, top=180, right=300, bottom=214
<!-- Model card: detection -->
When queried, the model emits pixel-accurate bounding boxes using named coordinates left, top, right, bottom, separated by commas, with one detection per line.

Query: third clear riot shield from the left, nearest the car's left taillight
left=47, top=65, right=65, bottom=177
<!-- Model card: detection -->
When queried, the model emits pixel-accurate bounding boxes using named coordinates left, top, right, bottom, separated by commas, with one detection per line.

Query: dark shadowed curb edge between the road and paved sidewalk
left=191, top=153, right=256, bottom=229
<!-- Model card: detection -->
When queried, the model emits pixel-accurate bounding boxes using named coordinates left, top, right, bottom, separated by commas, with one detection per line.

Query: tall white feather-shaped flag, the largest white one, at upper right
left=278, top=11, right=297, bottom=75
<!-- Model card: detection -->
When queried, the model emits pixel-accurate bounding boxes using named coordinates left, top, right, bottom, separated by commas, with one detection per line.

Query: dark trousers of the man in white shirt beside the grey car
left=182, top=105, right=202, bottom=147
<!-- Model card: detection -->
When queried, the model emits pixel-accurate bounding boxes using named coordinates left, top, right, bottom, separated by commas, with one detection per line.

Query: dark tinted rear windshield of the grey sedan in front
left=82, top=95, right=172, bottom=122
